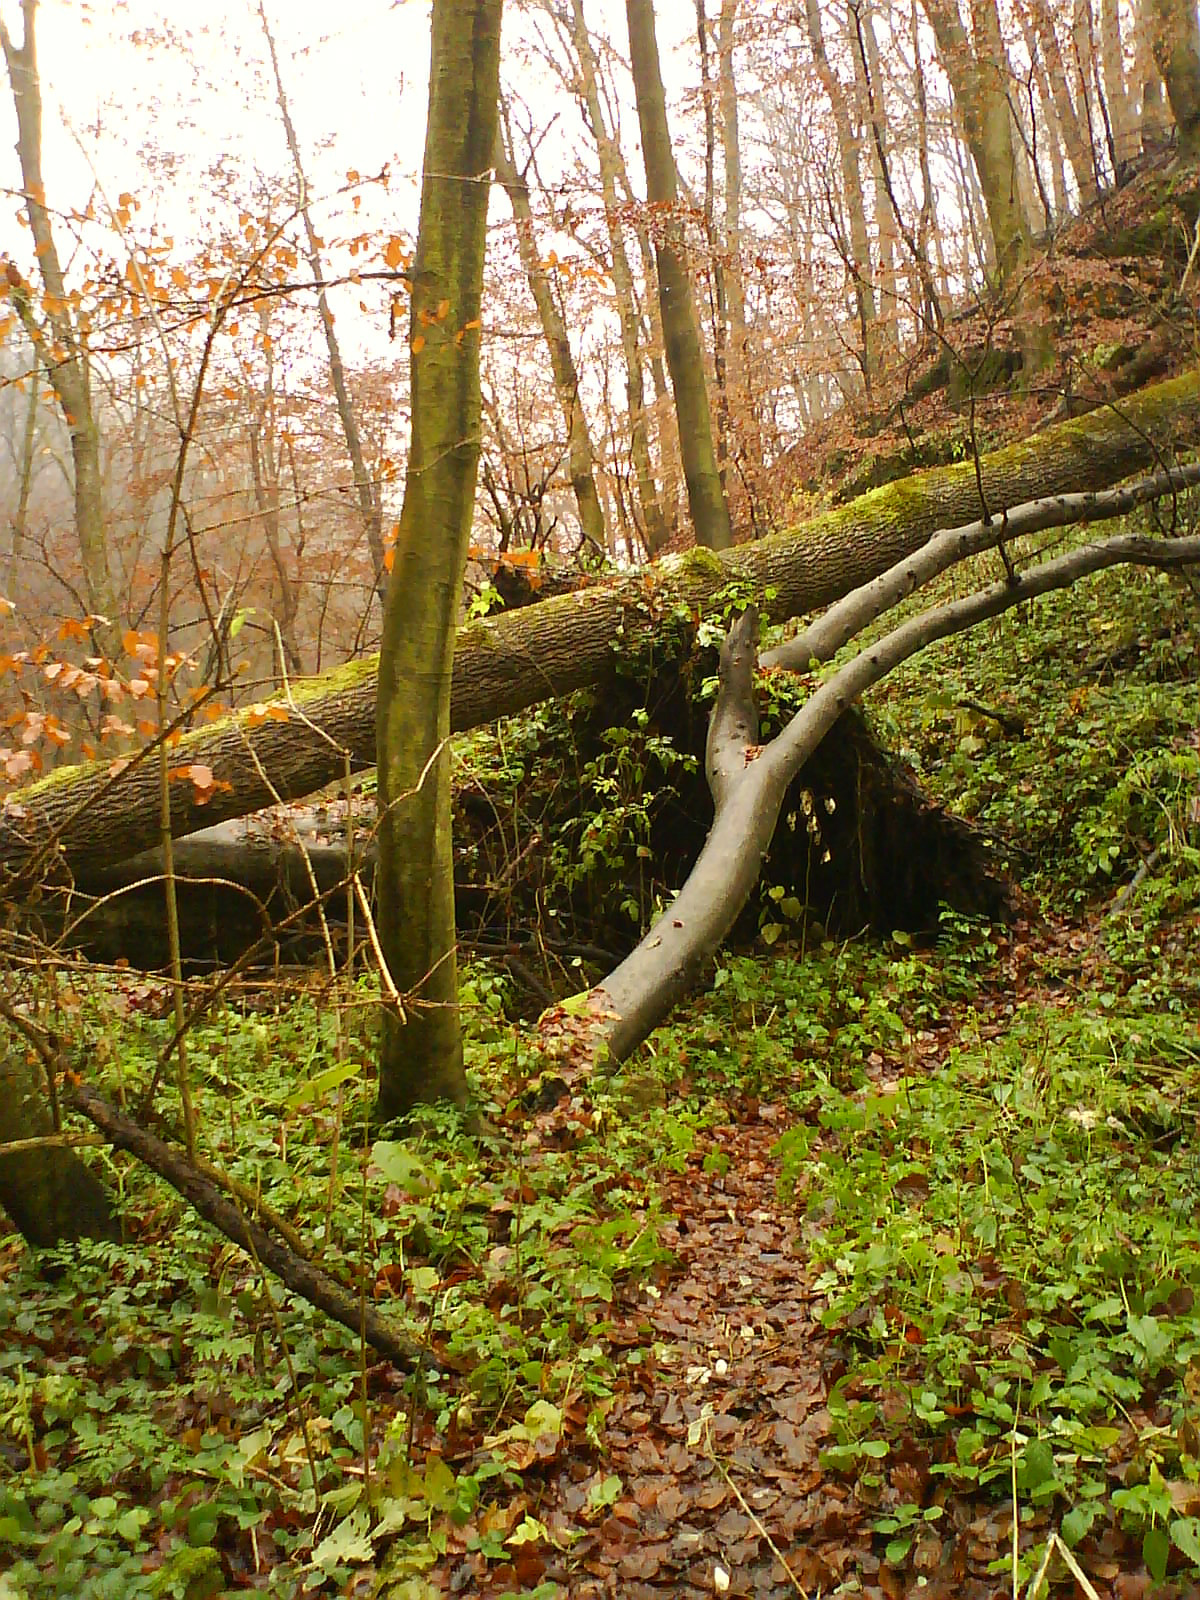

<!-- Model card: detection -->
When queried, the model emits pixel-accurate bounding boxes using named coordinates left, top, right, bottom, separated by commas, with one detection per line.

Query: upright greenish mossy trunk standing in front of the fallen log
left=376, top=0, right=501, bottom=1118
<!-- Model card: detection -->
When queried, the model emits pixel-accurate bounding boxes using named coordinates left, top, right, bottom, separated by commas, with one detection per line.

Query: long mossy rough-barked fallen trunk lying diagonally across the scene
left=0, top=371, right=1200, bottom=893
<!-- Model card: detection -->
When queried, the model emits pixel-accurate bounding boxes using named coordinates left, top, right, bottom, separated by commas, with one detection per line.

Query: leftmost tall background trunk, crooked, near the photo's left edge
left=0, top=0, right=122, bottom=658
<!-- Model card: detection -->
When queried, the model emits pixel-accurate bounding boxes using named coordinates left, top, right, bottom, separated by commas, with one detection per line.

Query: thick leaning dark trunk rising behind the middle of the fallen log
left=626, top=0, right=733, bottom=550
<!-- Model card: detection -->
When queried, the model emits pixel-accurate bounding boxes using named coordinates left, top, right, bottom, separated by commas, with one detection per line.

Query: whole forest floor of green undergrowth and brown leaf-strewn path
left=0, top=540, right=1200, bottom=1600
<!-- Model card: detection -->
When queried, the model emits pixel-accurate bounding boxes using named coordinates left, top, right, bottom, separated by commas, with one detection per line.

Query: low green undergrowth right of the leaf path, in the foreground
left=779, top=953, right=1200, bottom=1576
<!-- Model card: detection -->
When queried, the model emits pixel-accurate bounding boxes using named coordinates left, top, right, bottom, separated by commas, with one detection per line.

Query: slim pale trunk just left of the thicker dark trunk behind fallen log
left=563, top=0, right=670, bottom=557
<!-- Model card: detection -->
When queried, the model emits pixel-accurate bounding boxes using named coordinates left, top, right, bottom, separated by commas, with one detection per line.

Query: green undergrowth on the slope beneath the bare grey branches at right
left=870, top=518, right=1200, bottom=909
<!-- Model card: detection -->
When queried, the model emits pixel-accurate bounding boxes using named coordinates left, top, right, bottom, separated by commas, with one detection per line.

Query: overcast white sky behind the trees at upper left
left=0, top=0, right=710, bottom=371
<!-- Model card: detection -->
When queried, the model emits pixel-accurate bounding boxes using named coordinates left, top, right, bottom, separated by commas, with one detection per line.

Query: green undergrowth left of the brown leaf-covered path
left=0, top=970, right=678, bottom=1600
